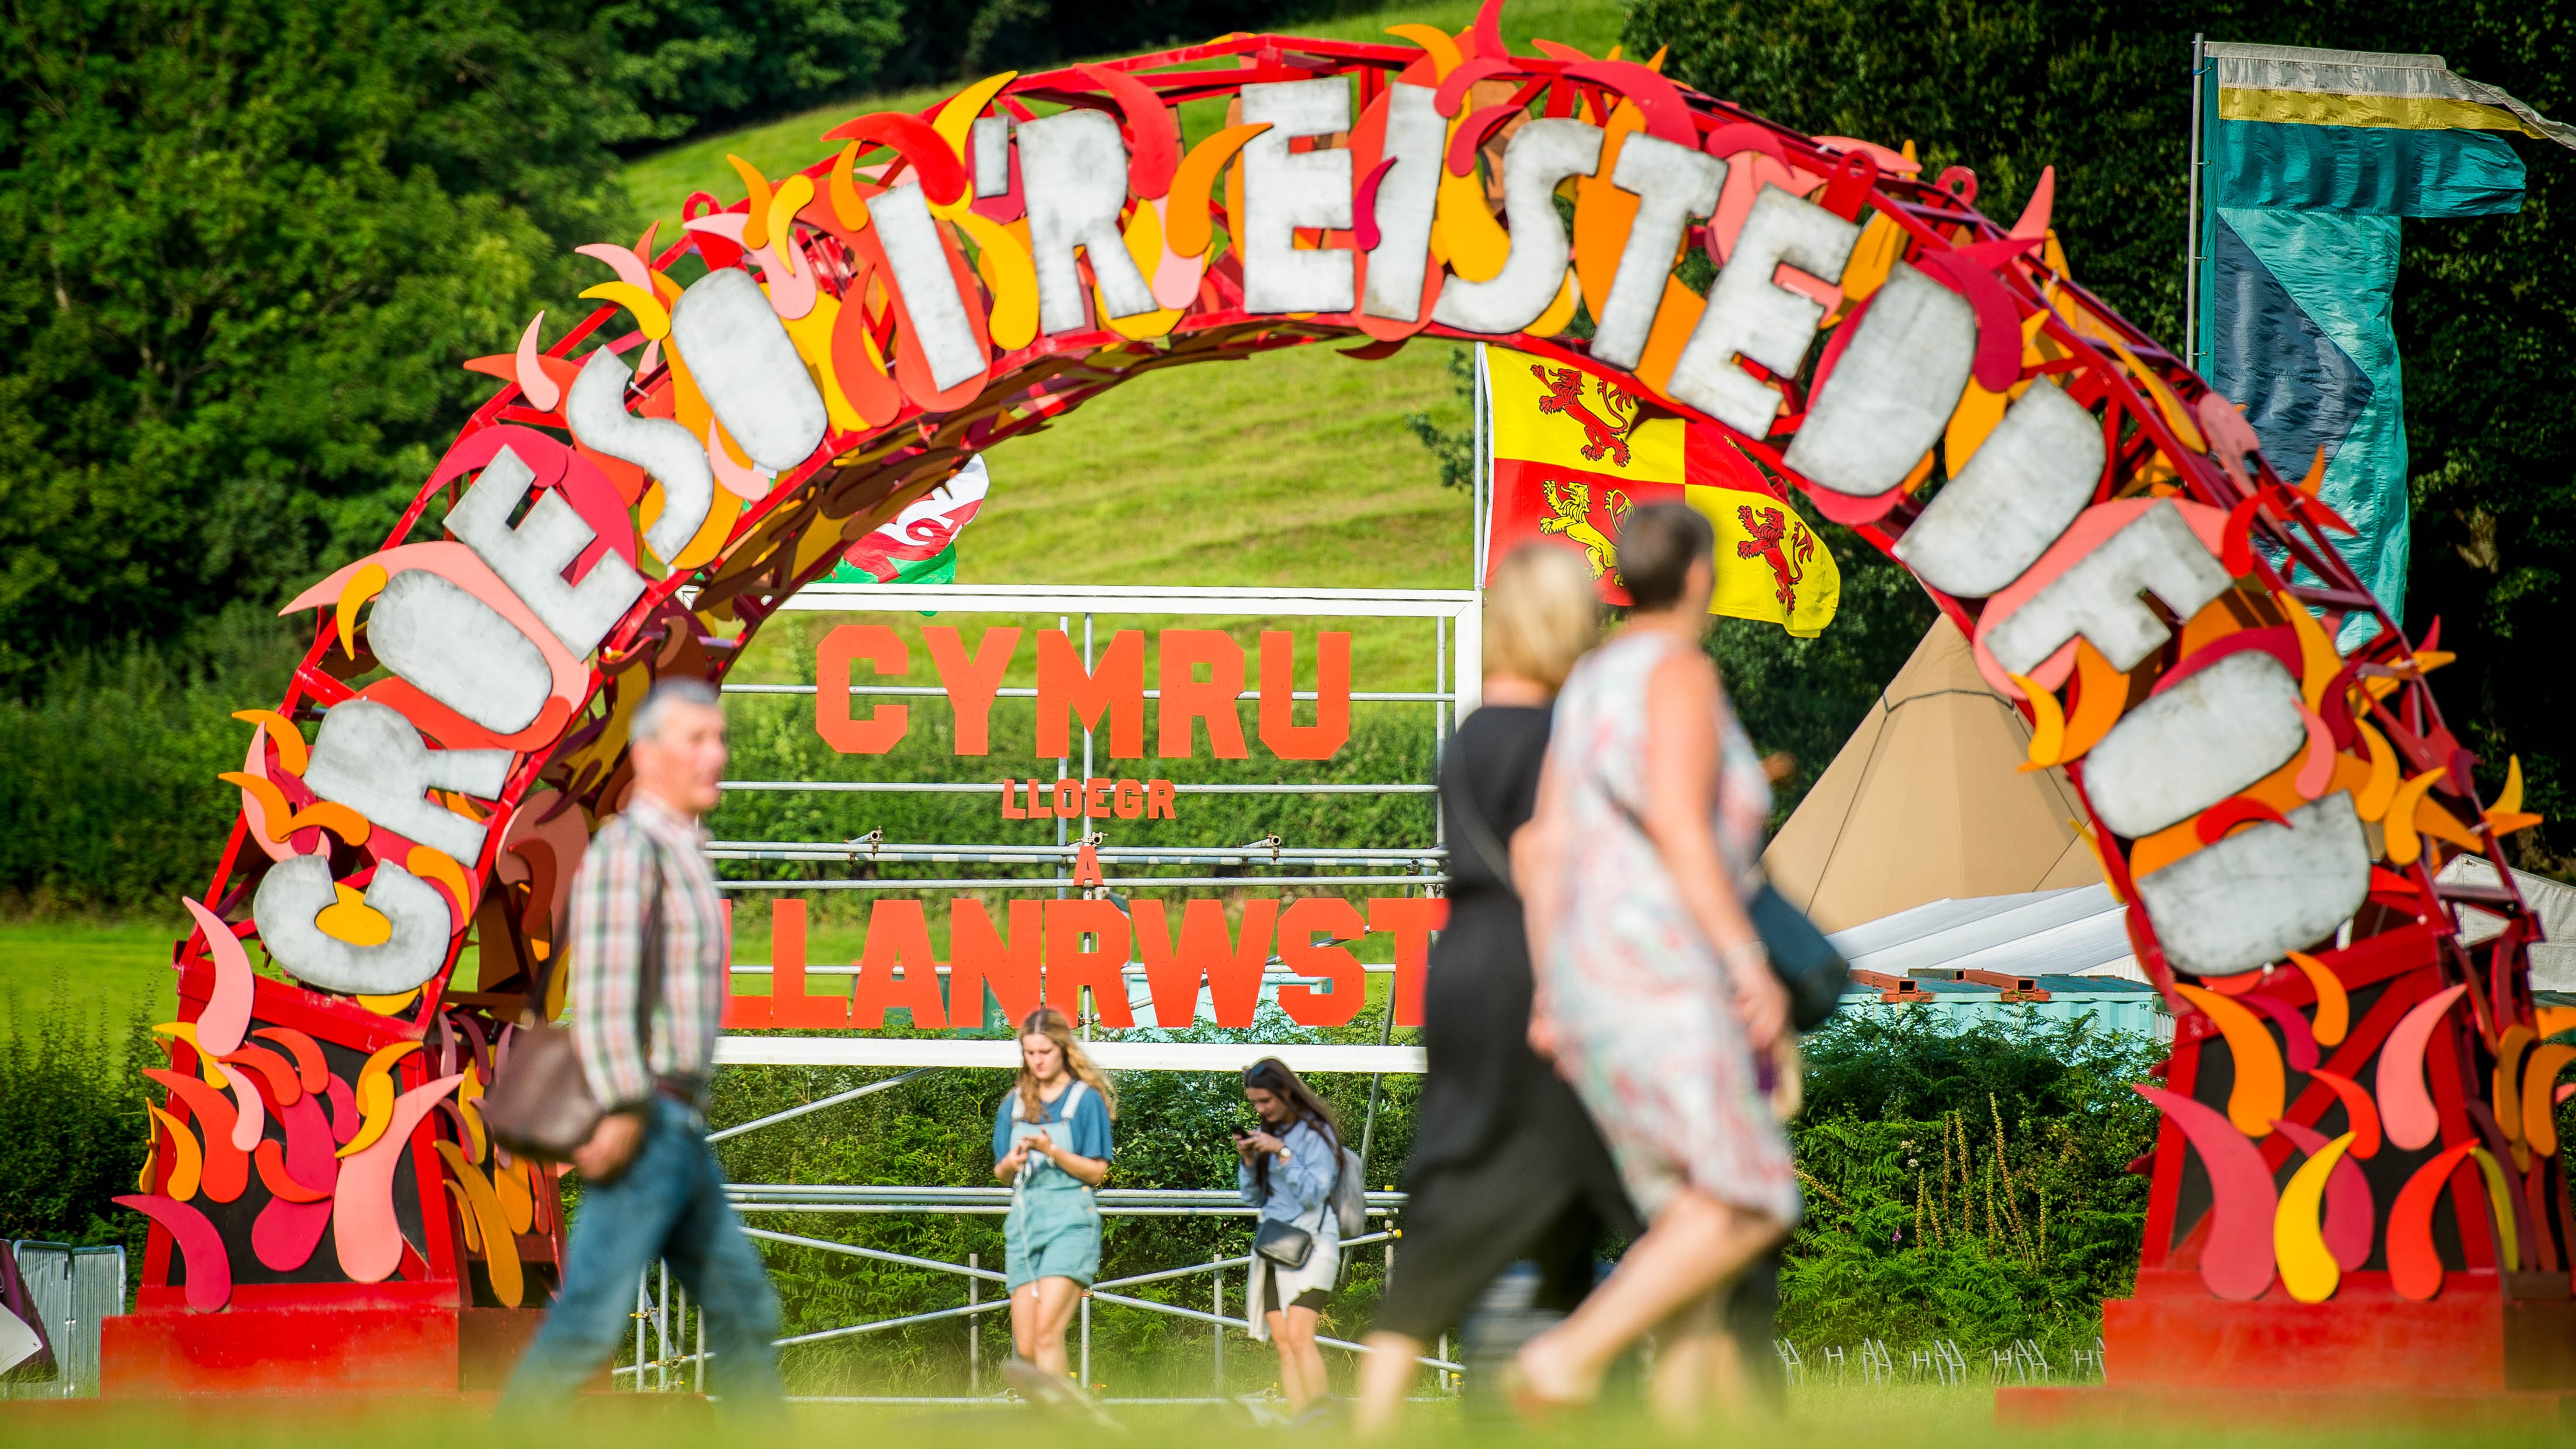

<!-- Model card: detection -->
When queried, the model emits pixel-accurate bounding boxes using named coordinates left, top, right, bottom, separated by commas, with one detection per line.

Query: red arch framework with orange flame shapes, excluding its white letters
left=134, top=11, right=2576, bottom=1392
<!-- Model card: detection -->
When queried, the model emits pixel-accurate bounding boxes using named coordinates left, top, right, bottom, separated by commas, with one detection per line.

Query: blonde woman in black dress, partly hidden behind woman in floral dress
left=1358, top=544, right=1641, bottom=1436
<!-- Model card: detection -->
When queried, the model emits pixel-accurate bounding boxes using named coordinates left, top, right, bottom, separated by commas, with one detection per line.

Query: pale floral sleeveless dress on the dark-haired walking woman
left=1540, top=629, right=1798, bottom=1222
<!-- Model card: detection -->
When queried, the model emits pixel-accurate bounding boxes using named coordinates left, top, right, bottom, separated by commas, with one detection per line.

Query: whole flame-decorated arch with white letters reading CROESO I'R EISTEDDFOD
left=141, top=14, right=2576, bottom=1351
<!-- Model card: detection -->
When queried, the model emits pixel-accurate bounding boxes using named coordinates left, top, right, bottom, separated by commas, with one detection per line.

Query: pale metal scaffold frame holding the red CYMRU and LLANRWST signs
left=664, top=583, right=1484, bottom=1403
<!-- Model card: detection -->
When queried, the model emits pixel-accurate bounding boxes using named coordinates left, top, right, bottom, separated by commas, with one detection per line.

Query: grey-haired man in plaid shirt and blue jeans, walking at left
left=503, top=678, right=783, bottom=1413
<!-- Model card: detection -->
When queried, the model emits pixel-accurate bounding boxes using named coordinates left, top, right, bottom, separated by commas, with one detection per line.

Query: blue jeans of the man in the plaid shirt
left=503, top=1096, right=783, bottom=1413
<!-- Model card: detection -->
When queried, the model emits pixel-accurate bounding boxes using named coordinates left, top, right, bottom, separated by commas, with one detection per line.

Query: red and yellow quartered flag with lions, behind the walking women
left=1486, top=348, right=1842, bottom=639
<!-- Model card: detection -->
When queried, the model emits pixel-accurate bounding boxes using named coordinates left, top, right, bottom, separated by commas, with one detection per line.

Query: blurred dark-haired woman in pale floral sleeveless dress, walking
left=1515, top=503, right=1798, bottom=1423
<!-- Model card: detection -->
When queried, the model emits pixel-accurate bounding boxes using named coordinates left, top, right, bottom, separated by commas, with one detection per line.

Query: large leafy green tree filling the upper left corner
left=0, top=0, right=636, bottom=691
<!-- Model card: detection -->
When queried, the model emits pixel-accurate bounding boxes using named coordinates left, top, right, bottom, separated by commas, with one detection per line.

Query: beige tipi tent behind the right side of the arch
left=1762, top=614, right=2102, bottom=931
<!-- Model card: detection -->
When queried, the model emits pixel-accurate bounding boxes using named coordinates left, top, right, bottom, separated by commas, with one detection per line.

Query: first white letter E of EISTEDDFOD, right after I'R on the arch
left=1244, top=75, right=1360, bottom=312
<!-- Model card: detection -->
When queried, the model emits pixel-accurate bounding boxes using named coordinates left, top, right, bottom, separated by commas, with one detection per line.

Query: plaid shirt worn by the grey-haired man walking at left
left=567, top=794, right=726, bottom=1109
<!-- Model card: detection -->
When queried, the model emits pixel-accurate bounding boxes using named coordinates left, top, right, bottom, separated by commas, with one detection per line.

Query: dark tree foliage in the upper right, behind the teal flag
left=1625, top=0, right=2576, bottom=872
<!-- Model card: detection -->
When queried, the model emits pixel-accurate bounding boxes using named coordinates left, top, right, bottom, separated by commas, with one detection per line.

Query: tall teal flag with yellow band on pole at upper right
left=2192, top=44, right=2576, bottom=650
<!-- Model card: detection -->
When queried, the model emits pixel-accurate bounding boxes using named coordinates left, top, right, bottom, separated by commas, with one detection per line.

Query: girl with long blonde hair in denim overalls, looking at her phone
left=992, top=1005, right=1118, bottom=1400
